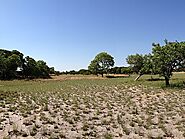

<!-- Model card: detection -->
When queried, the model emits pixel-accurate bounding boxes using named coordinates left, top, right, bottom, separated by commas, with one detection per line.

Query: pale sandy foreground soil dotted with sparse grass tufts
left=0, top=84, right=185, bottom=139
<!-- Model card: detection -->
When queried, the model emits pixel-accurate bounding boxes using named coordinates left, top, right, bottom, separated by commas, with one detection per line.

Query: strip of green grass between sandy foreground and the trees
left=0, top=73, right=185, bottom=92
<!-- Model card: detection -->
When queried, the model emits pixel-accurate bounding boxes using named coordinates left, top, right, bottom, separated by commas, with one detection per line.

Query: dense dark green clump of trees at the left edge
left=0, top=49, right=55, bottom=80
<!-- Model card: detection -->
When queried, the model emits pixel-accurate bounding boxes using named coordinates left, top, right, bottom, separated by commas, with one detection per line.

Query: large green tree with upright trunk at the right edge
left=152, top=41, right=185, bottom=86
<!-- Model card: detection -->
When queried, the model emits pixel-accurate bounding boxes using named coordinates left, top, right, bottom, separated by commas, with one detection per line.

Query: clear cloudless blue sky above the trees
left=0, top=0, right=185, bottom=71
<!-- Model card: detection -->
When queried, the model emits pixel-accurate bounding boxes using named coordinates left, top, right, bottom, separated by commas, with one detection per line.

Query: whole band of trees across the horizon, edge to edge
left=0, top=40, right=185, bottom=86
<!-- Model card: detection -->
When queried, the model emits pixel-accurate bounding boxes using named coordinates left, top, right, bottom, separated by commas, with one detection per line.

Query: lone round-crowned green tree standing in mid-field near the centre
left=88, top=52, right=114, bottom=77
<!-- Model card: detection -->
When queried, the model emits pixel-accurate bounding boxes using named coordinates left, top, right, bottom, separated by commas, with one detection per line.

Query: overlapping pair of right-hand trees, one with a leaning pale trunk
left=126, top=40, right=185, bottom=86
